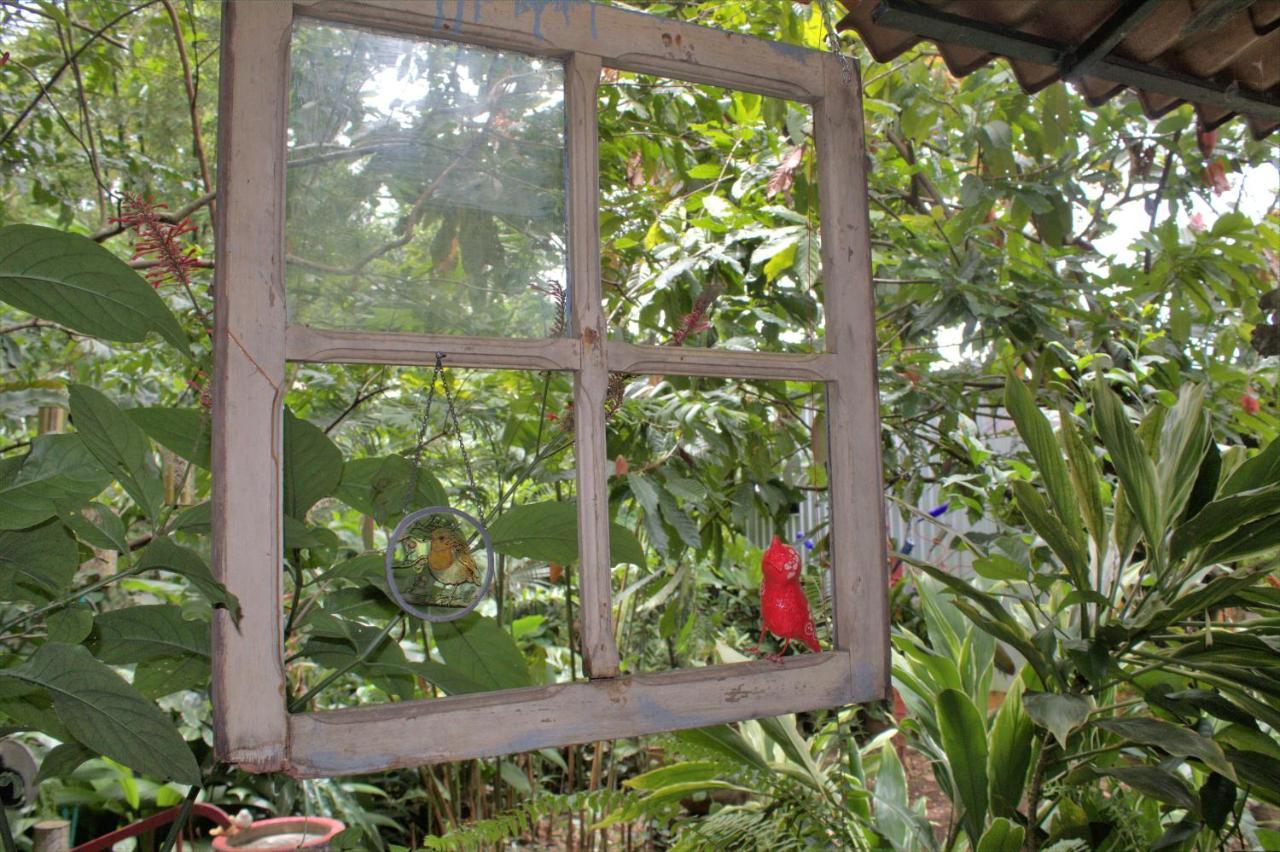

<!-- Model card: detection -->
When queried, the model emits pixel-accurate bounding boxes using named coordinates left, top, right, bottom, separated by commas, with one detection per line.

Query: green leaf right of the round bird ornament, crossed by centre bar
left=489, top=500, right=645, bottom=565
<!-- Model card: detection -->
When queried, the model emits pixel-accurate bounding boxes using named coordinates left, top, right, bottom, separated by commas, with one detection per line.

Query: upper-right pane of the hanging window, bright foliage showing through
left=599, top=69, right=823, bottom=352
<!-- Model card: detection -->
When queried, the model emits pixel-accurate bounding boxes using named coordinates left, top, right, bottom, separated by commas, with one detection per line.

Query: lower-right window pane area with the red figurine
left=609, top=376, right=831, bottom=672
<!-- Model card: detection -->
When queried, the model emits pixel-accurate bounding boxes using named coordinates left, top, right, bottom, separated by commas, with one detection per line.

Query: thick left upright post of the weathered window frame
left=212, top=3, right=292, bottom=771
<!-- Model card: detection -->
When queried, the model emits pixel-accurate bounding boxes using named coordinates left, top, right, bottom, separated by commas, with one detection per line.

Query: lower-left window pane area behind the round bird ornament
left=280, top=363, right=581, bottom=709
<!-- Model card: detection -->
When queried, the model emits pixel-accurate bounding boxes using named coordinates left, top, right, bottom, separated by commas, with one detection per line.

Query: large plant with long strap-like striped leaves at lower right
left=896, top=376, right=1280, bottom=848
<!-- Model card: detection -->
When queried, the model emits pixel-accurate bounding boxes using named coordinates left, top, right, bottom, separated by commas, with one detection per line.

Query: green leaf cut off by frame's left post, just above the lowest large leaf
left=93, top=604, right=209, bottom=665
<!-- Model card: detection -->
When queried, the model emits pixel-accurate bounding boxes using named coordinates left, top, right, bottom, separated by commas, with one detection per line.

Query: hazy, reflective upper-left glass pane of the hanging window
left=285, top=22, right=566, bottom=338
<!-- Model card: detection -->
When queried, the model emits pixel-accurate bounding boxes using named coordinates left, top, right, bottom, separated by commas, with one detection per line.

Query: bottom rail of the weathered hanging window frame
left=289, top=651, right=865, bottom=778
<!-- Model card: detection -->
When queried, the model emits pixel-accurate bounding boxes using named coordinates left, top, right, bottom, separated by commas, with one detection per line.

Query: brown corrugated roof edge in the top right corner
left=837, top=0, right=1280, bottom=138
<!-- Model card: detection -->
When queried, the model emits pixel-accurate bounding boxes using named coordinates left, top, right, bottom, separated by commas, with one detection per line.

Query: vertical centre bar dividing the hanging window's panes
left=564, top=54, right=618, bottom=678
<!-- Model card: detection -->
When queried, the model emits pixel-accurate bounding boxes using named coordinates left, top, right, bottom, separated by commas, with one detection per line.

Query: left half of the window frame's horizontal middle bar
left=284, top=325, right=581, bottom=370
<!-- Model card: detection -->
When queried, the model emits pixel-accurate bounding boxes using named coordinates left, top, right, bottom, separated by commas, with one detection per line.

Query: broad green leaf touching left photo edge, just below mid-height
left=0, top=435, right=111, bottom=530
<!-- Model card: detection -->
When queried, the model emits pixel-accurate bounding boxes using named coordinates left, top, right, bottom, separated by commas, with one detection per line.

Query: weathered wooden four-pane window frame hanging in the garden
left=212, top=0, right=890, bottom=777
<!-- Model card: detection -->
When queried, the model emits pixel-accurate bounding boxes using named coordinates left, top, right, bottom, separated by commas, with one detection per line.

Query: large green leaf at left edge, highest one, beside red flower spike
left=0, top=225, right=189, bottom=354
